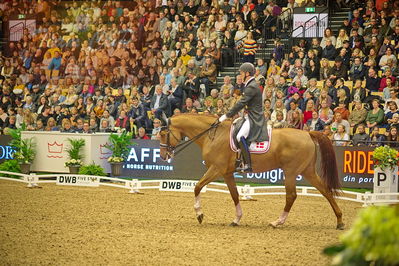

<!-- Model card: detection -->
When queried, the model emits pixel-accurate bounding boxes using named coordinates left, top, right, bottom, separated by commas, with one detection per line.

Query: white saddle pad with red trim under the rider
left=230, top=117, right=272, bottom=153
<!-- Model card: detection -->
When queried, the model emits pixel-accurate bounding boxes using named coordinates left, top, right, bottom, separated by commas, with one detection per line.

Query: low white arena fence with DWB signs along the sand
left=0, top=171, right=399, bottom=206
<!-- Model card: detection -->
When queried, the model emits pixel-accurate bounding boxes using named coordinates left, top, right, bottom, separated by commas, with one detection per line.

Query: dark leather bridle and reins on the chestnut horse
left=159, top=119, right=220, bottom=158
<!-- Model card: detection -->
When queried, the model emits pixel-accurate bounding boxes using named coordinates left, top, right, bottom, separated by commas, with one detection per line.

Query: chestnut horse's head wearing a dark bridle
left=159, top=119, right=182, bottom=161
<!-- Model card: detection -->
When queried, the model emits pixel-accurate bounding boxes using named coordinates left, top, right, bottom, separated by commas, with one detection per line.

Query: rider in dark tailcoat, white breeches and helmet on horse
left=219, top=63, right=268, bottom=172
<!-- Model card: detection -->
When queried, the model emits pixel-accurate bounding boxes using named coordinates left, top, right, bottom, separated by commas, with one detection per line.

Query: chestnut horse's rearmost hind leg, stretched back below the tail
left=303, top=169, right=345, bottom=230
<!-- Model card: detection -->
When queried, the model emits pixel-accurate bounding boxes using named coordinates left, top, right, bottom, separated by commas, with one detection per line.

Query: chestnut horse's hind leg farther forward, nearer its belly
left=270, top=172, right=297, bottom=228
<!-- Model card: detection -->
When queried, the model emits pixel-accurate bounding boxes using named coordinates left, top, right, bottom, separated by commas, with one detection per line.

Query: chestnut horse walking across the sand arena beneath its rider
left=160, top=114, right=344, bottom=229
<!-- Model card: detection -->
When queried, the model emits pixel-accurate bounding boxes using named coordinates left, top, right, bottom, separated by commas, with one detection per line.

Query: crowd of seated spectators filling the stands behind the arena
left=0, top=0, right=399, bottom=147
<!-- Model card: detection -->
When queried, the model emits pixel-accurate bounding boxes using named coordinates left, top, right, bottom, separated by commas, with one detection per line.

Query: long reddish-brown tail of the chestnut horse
left=309, top=131, right=341, bottom=195
